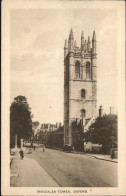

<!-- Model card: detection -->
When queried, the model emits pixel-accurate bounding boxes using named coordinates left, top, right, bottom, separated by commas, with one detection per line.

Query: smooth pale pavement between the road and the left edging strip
left=19, top=157, right=58, bottom=187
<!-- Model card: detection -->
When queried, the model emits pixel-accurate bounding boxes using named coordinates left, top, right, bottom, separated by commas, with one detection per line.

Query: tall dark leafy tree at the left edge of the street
left=10, top=95, right=32, bottom=147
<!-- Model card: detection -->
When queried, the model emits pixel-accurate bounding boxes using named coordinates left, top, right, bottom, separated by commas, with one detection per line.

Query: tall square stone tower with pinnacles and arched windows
left=64, top=29, right=97, bottom=145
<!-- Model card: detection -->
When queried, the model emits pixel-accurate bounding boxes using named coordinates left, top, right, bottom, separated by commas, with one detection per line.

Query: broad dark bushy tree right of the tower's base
left=84, top=114, right=117, bottom=151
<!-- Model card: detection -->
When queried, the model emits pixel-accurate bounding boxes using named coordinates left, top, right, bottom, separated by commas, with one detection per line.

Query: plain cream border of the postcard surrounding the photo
left=1, top=0, right=126, bottom=196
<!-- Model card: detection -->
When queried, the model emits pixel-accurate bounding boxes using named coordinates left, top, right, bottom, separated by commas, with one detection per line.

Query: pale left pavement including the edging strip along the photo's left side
left=10, top=149, right=59, bottom=187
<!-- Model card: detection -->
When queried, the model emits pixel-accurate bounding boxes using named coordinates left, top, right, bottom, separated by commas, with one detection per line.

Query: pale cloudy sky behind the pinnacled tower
left=10, top=9, right=117, bottom=123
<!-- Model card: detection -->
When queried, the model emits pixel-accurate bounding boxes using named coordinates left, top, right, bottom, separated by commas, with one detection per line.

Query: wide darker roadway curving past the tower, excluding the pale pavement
left=22, top=148, right=118, bottom=187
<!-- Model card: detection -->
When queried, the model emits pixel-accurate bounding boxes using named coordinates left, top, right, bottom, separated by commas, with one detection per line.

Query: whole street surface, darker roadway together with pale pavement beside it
left=19, top=148, right=118, bottom=187
